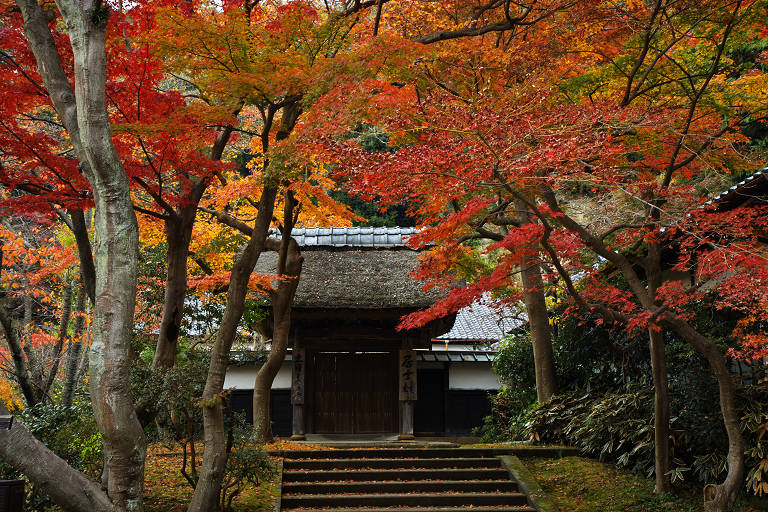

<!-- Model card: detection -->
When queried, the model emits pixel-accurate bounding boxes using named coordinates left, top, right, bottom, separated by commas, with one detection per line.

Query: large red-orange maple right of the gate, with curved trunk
left=308, top=1, right=766, bottom=510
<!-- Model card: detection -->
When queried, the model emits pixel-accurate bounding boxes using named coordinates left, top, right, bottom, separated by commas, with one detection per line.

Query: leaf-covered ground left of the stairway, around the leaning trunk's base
left=144, top=445, right=277, bottom=512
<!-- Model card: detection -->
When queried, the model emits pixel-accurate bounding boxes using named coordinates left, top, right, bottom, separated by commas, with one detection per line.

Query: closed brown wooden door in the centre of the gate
left=306, top=352, right=398, bottom=434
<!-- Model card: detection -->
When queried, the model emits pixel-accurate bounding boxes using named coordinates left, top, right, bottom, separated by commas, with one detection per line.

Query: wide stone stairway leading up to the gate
left=281, top=448, right=535, bottom=512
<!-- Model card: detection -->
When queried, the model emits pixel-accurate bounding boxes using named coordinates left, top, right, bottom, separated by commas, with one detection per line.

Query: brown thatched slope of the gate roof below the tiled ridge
left=256, top=246, right=441, bottom=309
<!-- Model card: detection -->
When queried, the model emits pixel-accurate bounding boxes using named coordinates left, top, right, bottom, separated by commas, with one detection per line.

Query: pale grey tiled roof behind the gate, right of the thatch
left=436, top=300, right=528, bottom=341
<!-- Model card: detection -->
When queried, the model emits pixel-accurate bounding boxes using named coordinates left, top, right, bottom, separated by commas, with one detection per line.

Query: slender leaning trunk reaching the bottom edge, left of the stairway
left=187, top=184, right=277, bottom=512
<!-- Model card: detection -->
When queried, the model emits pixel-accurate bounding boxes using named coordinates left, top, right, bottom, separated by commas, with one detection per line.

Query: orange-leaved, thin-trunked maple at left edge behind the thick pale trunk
left=0, top=211, right=87, bottom=409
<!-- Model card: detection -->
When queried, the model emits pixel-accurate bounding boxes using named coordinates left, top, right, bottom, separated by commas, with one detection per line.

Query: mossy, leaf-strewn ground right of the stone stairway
left=523, top=457, right=758, bottom=512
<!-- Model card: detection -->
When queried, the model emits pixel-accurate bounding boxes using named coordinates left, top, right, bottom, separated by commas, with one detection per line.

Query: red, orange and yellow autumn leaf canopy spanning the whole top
left=0, top=0, right=768, bottom=508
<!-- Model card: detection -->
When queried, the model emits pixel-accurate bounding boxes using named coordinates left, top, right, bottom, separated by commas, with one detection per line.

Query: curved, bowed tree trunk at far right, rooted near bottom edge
left=661, top=315, right=744, bottom=512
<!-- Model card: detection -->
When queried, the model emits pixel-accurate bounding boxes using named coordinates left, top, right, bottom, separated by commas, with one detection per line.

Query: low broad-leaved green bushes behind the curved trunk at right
left=507, top=381, right=768, bottom=495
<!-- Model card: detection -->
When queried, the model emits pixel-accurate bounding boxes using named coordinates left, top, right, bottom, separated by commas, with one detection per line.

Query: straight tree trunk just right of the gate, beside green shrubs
left=515, top=199, right=557, bottom=403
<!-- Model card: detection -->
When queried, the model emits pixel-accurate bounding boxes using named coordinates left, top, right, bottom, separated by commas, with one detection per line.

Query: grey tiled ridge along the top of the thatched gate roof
left=275, top=227, right=416, bottom=247
